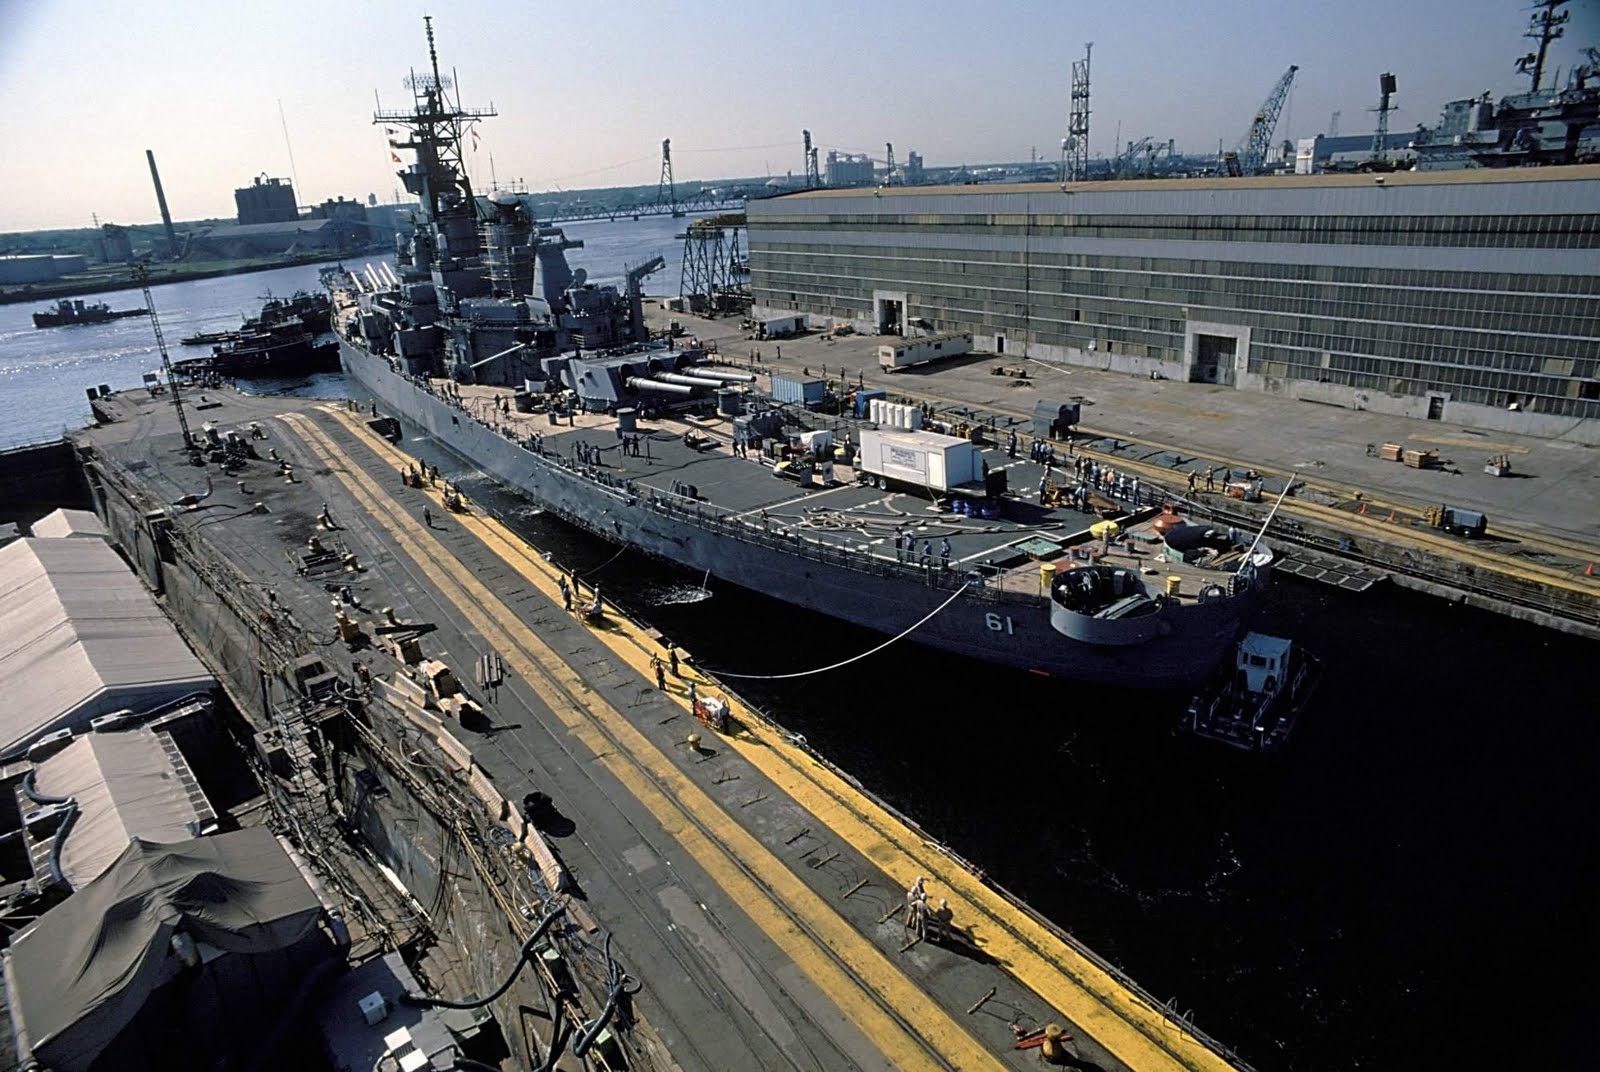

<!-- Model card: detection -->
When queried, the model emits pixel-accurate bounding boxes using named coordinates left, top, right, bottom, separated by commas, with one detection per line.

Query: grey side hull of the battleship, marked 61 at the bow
left=339, top=338, right=1258, bottom=688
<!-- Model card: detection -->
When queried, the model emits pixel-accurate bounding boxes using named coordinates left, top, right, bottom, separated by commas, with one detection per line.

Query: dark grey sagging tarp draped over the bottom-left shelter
left=10, top=827, right=322, bottom=1069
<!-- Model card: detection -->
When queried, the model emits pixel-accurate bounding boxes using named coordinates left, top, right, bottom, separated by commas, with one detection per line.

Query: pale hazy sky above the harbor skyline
left=0, top=0, right=1600, bottom=232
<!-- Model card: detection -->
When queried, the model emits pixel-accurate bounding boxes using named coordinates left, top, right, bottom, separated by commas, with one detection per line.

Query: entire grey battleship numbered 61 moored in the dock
left=325, top=24, right=1274, bottom=688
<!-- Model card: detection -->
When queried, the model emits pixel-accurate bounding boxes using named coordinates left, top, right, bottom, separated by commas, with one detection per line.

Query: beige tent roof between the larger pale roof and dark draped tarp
left=34, top=728, right=209, bottom=890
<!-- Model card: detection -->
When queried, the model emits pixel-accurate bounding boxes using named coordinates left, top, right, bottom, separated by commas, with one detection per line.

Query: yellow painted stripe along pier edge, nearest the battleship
left=312, top=414, right=1230, bottom=1069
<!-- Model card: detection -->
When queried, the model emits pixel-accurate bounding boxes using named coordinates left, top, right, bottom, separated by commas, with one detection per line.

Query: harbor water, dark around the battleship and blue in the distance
left=0, top=219, right=1600, bottom=1070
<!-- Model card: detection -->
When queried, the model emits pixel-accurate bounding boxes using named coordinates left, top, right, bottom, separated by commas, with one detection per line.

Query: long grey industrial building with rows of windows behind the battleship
left=747, top=165, right=1600, bottom=442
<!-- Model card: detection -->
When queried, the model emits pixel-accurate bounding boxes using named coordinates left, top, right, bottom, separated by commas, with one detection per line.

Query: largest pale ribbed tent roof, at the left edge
left=0, top=539, right=216, bottom=750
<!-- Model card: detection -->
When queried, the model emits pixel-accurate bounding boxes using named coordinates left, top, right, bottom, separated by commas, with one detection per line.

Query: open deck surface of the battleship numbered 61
left=434, top=381, right=1248, bottom=602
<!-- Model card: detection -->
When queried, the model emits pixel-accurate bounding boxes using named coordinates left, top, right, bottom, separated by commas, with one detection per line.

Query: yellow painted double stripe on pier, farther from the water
left=283, top=414, right=1003, bottom=1069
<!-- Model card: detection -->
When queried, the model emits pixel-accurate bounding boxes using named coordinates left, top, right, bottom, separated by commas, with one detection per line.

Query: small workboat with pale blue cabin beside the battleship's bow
left=1184, top=632, right=1322, bottom=752
